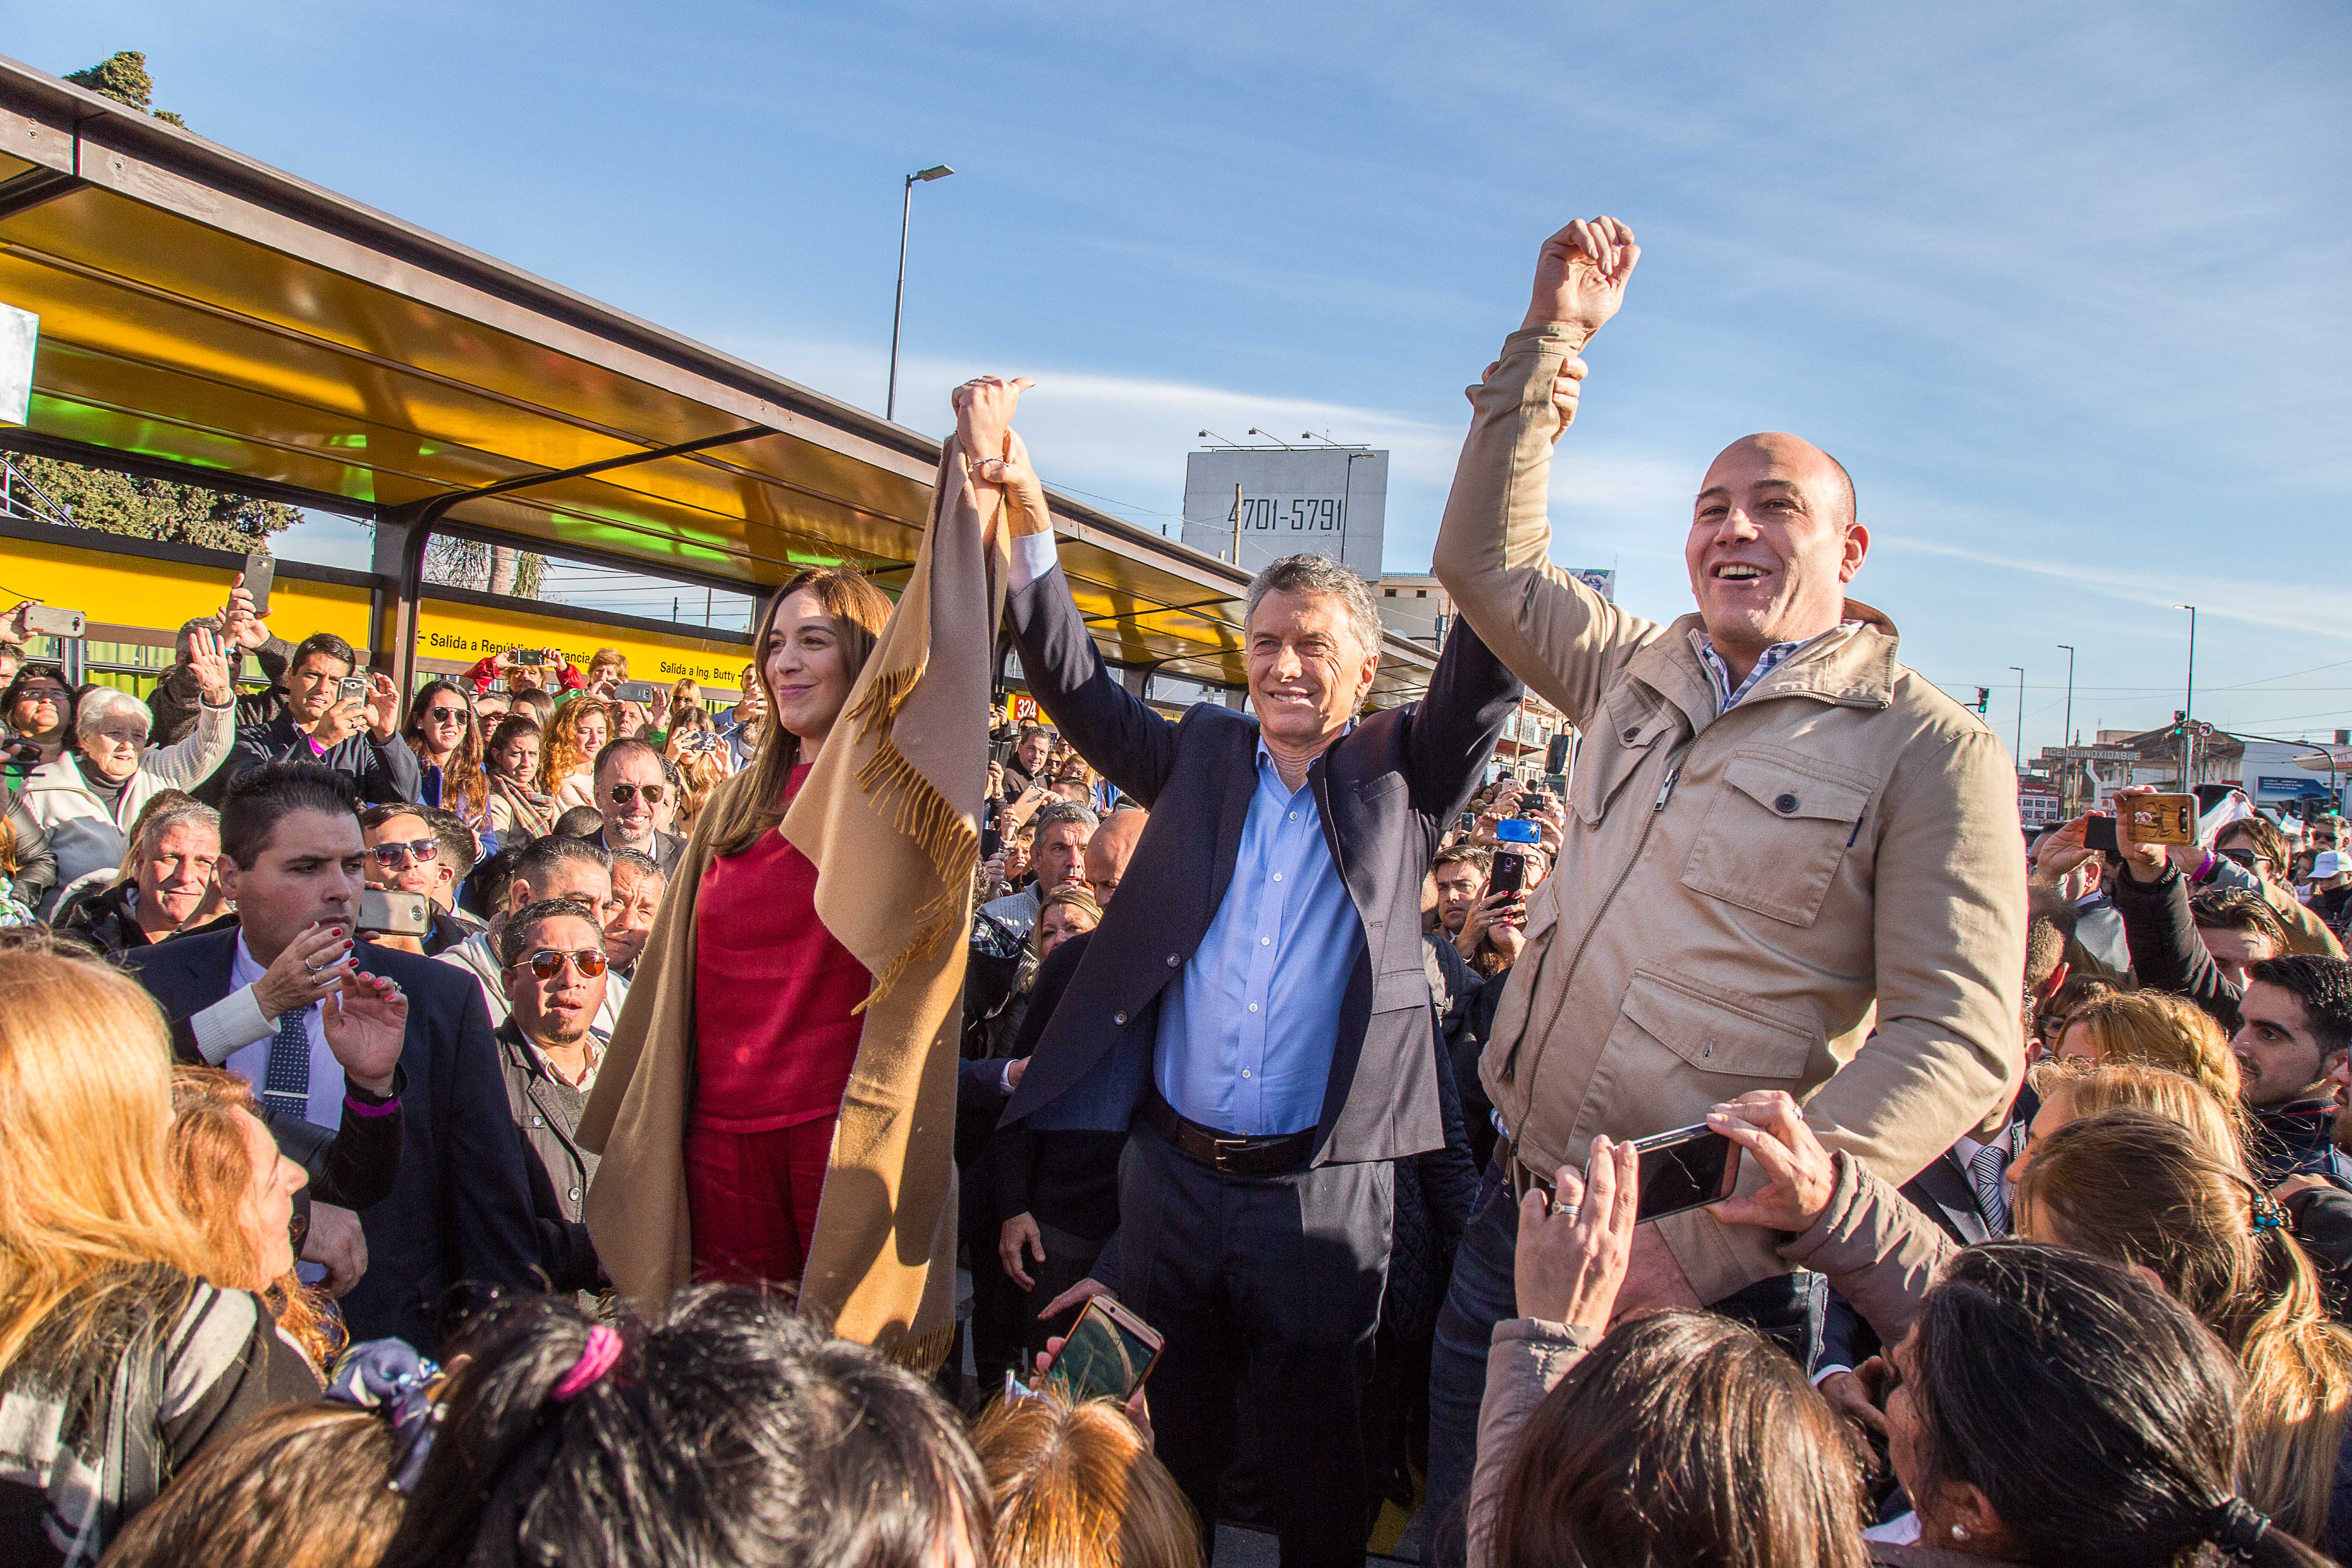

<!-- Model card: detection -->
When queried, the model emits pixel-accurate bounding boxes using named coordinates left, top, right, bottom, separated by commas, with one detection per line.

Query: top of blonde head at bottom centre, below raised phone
left=971, top=1382, right=1200, bottom=1568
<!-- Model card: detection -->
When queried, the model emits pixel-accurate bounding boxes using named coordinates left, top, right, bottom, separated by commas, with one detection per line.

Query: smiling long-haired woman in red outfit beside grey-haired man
left=583, top=569, right=891, bottom=1286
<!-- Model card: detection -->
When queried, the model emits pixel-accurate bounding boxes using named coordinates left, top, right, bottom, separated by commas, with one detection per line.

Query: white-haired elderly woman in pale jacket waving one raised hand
left=21, top=630, right=238, bottom=915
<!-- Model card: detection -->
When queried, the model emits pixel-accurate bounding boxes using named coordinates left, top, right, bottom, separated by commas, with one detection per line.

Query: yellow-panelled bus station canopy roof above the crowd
left=0, top=59, right=1432, bottom=705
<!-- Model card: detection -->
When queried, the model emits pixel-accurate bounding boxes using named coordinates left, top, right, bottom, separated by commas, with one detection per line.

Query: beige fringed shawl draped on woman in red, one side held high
left=581, top=440, right=1009, bottom=1371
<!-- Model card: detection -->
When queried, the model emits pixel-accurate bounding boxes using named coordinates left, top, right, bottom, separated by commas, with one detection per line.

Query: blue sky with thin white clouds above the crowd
left=18, top=0, right=2352, bottom=752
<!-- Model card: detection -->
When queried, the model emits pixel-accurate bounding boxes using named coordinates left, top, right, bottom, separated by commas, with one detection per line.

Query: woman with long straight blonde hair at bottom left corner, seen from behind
left=0, top=943, right=320, bottom=1568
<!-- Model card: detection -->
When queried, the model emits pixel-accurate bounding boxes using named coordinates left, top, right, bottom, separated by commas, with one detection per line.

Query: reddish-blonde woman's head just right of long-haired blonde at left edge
left=172, top=1067, right=343, bottom=1371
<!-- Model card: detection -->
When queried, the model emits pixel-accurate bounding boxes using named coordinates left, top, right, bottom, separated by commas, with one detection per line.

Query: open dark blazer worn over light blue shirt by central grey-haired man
left=1004, top=567, right=1519, bottom=1164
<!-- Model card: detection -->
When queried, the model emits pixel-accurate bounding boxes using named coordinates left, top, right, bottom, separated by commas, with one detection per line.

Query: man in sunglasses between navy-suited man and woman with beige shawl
left=499, top=898, right=612, bottom=1291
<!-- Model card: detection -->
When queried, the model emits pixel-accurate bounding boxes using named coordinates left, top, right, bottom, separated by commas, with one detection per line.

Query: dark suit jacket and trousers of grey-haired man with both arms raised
left=1004, top=567, right=1519, bottom=1563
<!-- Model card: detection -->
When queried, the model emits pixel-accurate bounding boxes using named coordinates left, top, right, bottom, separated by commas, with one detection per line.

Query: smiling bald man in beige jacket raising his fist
left=1430, top=219, right=2025, bottom=1561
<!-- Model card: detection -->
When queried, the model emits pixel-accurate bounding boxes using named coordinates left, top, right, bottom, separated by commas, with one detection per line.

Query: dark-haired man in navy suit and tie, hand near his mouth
left=125, top=764, right=539, bottom=1354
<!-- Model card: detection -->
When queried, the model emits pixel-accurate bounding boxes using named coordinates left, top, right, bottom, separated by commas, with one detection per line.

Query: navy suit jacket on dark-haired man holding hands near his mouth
left=125, top=926, right=541, bottom=1357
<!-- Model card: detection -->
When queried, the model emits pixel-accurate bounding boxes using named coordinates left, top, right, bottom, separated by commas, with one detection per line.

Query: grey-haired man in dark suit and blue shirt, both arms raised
left=943, top=381, right=1519, bottom=1563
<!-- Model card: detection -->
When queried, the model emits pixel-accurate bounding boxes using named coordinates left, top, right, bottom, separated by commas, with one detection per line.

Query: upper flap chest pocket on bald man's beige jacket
left=1681, top=752, right=1870, bottom=926
